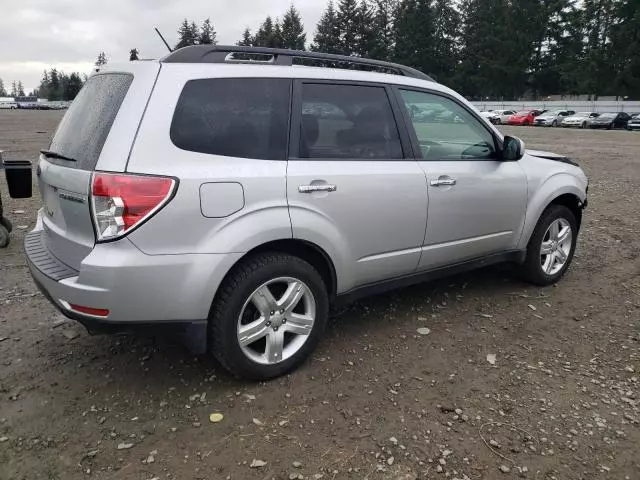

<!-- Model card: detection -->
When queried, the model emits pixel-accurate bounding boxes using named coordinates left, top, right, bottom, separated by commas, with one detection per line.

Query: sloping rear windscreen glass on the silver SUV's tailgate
left=49, top=73, right=133, bottom=170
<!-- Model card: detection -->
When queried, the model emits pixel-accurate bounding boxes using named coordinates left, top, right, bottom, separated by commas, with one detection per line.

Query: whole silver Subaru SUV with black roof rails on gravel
left=25, top=46, right=587, bottom=379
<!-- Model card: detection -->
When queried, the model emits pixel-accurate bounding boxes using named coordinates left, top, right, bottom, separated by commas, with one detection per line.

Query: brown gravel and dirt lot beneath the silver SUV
left=0, top=111, right=640, bottom=480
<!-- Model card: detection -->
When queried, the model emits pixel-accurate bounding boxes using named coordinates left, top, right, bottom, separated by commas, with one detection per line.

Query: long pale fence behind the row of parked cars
left=472, top=100, right=640, bottom=113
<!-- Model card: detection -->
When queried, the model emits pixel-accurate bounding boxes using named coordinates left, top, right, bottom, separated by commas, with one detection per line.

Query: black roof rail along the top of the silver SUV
left=160, top=45, right=435, bottom=82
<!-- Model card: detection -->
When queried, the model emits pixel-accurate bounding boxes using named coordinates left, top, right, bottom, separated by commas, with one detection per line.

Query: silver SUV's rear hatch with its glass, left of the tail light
left=37, top=62, right=160, bottom=270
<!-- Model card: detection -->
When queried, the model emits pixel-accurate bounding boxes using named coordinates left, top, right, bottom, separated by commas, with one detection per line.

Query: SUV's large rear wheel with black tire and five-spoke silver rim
left=209, top=253, right=329, bottom=380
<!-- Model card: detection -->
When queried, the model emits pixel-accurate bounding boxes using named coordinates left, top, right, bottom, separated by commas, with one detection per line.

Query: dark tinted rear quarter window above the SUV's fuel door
left=171, top=78, right=291, bottom=160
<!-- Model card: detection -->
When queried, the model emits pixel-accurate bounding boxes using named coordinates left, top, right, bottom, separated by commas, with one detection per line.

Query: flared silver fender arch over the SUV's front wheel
left=518, top=172, right=587, bottom=250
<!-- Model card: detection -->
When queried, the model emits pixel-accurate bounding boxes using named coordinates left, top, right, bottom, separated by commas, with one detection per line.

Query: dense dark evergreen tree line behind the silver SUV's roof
left=175, top=0, right=640, bottom=99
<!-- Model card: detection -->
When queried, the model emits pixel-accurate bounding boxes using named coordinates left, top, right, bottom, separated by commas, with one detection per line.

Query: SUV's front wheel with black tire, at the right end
left=521, top=205, right=578, bottom=286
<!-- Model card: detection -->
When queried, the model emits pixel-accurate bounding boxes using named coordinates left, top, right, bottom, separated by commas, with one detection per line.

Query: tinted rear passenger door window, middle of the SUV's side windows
left=300, top=83, right=403, bottom=160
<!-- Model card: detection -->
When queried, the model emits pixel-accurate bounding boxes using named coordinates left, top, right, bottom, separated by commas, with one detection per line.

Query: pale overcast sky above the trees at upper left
left=0, top=0, right=326, bottom=93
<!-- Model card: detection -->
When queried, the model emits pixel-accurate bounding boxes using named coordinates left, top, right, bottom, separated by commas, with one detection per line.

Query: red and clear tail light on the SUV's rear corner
left=91, top=173, right=176, bottom=241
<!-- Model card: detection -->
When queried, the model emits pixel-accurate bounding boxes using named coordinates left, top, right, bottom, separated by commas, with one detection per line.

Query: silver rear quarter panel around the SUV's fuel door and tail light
left=127, top=64, right=292, bottom=255
